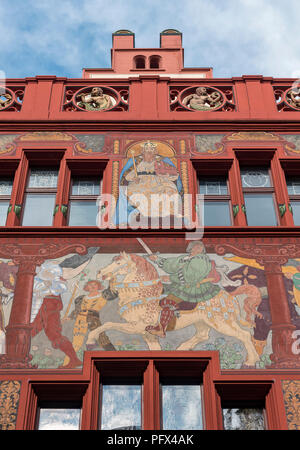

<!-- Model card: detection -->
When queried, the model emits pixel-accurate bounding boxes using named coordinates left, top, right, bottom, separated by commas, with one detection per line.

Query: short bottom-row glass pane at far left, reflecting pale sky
left=38, top=408, right=81, bottom=430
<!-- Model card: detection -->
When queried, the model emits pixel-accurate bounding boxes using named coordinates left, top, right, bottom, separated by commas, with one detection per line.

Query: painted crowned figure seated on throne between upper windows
left=115, top=141, right=183, bottom=224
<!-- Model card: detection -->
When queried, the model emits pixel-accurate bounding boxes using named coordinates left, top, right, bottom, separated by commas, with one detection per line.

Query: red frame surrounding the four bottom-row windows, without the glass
left=22, top=351, right=286, bottom=430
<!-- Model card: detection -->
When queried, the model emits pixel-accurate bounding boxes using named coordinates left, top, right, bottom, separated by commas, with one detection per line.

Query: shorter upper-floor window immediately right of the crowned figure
left=198, top=176, right=231, bottom=226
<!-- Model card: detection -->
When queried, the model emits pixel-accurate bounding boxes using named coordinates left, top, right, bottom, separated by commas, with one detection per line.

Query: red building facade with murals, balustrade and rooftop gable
left=0, top=30, right=300, bottom=430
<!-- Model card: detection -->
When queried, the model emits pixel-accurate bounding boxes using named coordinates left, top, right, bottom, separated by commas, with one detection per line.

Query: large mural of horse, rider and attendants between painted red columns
left=30, top=241, right=272, bottom=369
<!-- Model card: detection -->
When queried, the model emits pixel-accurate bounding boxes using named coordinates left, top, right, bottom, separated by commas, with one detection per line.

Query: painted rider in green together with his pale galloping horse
left=86, top=243, right=261, bottom=366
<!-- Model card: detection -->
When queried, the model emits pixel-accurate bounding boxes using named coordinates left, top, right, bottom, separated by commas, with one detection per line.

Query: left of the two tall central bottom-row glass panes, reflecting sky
left=101, top=384, right=142, bottom=430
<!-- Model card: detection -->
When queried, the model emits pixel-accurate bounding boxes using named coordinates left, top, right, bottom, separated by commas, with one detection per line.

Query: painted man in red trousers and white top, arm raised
left=31, top=248, right=98, bottom=369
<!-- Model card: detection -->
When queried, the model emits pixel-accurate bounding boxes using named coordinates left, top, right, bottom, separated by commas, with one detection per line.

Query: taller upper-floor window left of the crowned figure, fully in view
left=22, top=167, right=58, bottom=226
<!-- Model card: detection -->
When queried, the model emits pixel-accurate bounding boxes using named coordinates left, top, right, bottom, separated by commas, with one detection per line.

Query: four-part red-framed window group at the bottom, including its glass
left=24, top=351, right=278, bottom=430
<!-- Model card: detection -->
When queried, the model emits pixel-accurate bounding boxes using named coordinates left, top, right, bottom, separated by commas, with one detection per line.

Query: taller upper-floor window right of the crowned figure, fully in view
left=241, top=167, right=277, bottom=226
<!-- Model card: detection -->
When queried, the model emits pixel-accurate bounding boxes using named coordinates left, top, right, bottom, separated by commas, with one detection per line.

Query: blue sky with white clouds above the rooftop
left=0, top=0, right=300, bottom=78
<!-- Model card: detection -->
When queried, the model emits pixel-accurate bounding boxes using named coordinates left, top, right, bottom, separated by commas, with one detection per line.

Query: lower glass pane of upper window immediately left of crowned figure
left=69, top=200, right=98, bottom=227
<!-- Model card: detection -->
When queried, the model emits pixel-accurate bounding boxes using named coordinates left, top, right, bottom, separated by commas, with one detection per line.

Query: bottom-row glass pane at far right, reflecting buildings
left=223, top=408, right=265, bottom=430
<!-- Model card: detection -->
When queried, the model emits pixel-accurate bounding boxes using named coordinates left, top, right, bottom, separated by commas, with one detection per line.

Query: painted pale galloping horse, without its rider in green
left=86, top=251, right=259, bottom=367
